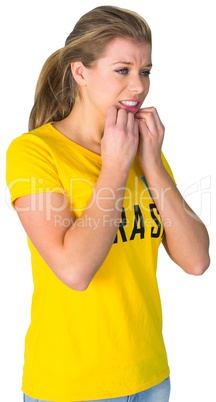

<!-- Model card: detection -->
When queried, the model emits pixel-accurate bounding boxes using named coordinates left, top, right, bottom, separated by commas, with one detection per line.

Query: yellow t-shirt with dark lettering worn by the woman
left=7, top=123, right=173, bottom=402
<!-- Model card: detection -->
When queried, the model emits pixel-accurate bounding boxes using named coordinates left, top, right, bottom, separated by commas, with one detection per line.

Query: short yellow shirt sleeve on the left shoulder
left=6, top=133, right=65, bottom=204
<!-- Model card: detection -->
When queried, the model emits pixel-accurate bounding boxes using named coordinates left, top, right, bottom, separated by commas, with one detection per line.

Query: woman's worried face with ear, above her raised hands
left=79, top=38, right=152, bottom=122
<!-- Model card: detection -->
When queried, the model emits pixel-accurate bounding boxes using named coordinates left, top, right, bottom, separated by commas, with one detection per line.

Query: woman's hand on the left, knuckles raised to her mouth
left=101, top=106, right=139, bottom=171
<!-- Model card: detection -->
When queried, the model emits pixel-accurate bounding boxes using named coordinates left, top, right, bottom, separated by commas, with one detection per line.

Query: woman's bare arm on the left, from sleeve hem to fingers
left=15, top=108, right=138, bottom=290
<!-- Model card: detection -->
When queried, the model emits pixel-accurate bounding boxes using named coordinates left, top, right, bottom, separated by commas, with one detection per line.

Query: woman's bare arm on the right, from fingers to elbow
left=136, top=108, right=210, bottom=275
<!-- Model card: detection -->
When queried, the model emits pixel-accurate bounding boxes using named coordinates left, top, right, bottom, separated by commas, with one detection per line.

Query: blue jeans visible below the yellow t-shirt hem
left=23, top=377, right=170, bottom=402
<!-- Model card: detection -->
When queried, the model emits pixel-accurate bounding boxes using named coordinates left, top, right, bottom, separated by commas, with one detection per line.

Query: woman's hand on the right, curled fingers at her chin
left=135, top=107, right=165, bottom=172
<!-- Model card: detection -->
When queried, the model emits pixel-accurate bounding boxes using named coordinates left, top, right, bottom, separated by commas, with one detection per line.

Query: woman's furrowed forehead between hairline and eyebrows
left=103, top=38, right=151, bottom=62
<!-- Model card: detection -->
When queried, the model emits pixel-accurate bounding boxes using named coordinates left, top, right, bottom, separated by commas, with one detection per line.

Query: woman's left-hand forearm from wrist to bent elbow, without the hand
left=60, top=169, right=127, bottom=290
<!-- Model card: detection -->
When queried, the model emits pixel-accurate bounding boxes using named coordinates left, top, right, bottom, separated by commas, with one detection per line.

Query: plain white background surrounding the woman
left=0, top=0, right=216, bottom=402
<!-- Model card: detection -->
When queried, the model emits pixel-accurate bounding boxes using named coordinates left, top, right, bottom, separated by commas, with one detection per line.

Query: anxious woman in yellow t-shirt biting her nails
left=7, top=6, right=209, bottom=402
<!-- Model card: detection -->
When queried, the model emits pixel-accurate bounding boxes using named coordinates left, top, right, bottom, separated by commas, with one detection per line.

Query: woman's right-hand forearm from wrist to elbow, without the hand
left=143, top=165, right=209, bottom=275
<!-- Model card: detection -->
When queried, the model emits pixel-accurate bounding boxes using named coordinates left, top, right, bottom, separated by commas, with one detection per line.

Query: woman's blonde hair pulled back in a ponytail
left=29, top=6, right=151, bottom=130
